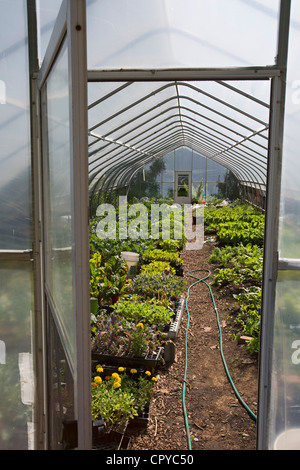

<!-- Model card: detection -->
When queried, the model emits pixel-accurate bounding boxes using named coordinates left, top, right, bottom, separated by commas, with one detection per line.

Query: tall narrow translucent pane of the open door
left=44, top=42, right=75, bottom=366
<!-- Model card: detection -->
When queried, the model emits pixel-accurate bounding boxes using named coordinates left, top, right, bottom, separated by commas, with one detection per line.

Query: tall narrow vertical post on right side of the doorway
left=257, top=0, right=291, bottom=449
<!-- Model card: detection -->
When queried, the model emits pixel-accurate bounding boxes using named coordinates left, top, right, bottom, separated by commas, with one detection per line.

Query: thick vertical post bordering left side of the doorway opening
left=67, top=0, right=92, bottom=450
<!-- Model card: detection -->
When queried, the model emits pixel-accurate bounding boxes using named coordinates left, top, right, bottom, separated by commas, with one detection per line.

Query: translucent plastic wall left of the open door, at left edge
left=0, top=0, right=34, bottom=450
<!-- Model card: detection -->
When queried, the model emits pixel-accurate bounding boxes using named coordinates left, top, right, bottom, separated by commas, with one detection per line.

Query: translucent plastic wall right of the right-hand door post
left=268, top=0, right=300, bottom=450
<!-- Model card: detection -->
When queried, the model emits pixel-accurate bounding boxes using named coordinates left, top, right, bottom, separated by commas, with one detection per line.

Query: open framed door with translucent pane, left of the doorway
left=38, top=0, right=91, bottom=450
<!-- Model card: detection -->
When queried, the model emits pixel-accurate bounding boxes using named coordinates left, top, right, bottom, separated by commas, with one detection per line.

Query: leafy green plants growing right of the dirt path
left=204, top=205, right=264, bottom=353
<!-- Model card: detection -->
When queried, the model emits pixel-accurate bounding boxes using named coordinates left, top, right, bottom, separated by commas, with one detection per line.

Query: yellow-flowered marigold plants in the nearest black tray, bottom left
left=92, top=366, right=157, bottom=428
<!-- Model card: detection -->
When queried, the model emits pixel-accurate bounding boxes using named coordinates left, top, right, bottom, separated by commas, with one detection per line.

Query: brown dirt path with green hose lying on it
left=129, top=239, right=258, bottom=451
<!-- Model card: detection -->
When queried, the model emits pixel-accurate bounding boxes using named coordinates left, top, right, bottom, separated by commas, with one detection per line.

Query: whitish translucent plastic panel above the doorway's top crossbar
left=87, top=0, right=279, bottom=69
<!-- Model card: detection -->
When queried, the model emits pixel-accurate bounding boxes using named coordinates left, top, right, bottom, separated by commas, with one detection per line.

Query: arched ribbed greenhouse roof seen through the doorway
left=89, top=80, right=274, bottom=201
